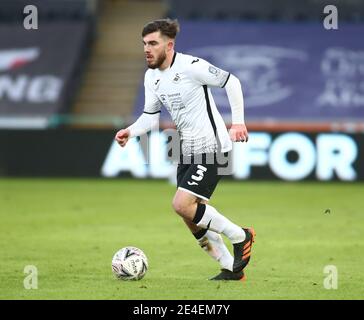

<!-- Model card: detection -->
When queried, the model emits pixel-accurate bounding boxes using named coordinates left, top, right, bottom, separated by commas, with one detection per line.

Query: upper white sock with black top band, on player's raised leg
left=193, top=203, right=245, bottom=244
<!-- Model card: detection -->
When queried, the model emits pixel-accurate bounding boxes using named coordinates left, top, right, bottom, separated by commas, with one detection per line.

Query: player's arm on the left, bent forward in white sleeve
left=115, top=73, right=161, bottom=147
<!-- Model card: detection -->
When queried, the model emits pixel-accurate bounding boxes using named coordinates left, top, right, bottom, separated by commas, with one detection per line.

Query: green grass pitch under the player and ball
left=0, top=179, right=364, bottom=300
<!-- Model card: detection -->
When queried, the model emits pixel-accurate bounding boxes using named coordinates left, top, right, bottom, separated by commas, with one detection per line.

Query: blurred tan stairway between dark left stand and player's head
left=73, top=0, right=166, bottom=125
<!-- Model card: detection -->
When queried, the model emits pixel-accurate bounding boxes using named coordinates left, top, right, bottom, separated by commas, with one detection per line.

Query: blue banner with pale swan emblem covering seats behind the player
left=134, top=21, right=364, bottom=122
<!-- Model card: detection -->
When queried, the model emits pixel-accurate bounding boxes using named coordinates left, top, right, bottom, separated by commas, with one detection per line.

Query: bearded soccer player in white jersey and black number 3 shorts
left=115, top=19, right=255, bottom=280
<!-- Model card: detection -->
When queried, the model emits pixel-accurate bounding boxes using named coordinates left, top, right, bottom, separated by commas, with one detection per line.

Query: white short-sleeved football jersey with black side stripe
left=144, top=53, right=232, bottom=155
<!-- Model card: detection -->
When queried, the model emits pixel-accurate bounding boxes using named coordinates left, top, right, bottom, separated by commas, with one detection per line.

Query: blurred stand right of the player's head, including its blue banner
left=129, top=0, right=364, bottom=132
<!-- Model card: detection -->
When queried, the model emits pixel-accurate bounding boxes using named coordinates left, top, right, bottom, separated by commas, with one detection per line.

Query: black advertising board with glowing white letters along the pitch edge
left=0, top=129, right=364, bottom=183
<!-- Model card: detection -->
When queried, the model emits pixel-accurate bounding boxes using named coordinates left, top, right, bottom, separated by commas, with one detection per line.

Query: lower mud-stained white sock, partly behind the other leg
left=197, top=230, right=234, bottom=271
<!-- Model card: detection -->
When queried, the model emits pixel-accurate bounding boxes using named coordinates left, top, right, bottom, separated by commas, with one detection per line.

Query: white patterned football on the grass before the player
left=111, top=247, right=148, bottom=280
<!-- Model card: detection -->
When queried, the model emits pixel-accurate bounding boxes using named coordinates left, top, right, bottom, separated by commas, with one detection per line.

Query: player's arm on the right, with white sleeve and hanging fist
left=188, top=58, right=248, bottom=141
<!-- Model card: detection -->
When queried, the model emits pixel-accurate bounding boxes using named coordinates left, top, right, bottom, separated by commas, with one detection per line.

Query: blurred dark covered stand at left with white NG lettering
left=0, top=0, right=97, bottom=127
